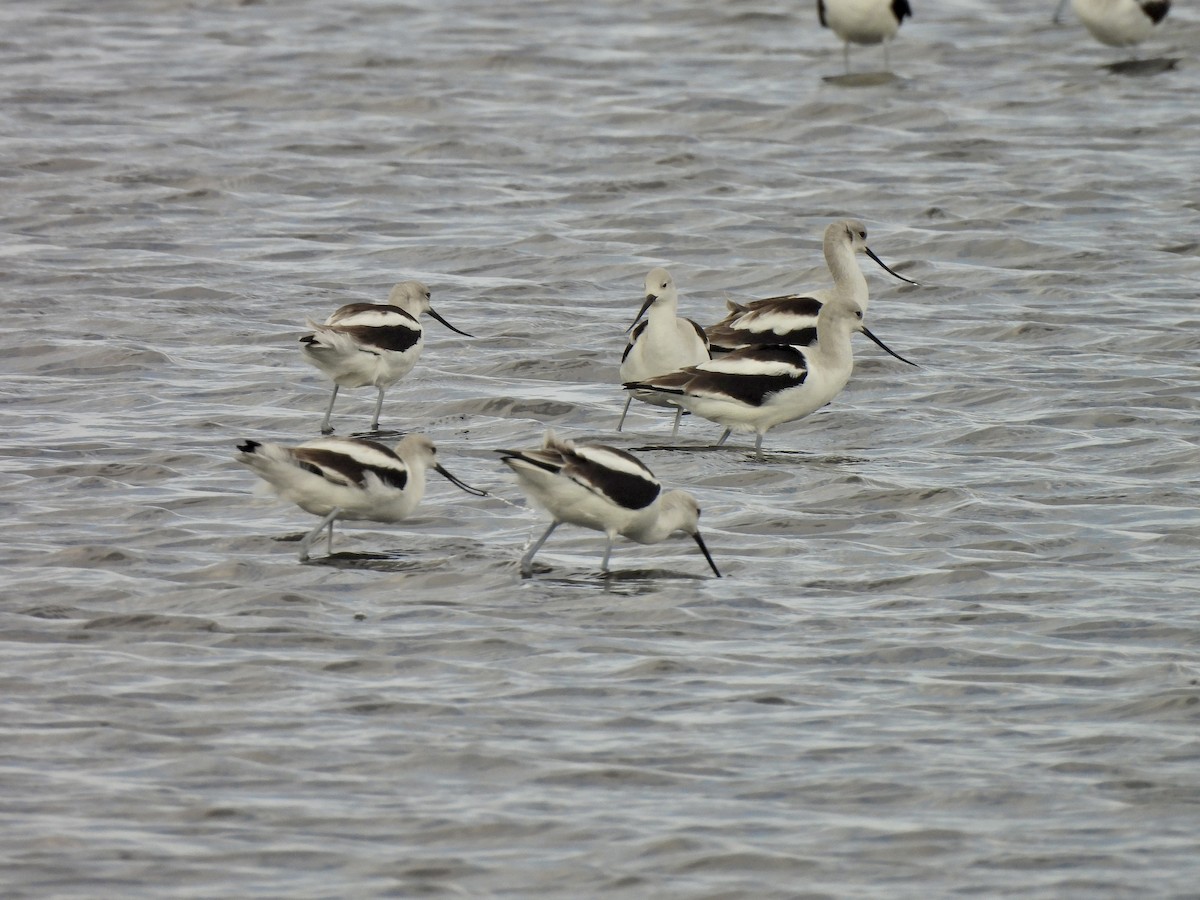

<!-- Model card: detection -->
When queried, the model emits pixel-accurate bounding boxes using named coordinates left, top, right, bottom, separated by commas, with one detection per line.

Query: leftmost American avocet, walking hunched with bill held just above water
left=236, top=434, right=486, bottom=562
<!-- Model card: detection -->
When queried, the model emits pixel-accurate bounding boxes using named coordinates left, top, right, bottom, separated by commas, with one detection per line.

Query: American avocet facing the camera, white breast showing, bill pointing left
left=617, top=269, right=710, bottom=437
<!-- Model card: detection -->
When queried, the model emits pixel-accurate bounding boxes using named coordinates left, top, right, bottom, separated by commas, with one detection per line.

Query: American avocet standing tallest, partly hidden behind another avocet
left=706, top=218, right=917, bottom=352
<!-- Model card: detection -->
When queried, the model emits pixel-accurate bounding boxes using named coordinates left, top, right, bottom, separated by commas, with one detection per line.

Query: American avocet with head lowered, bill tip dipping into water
left=497, top=431, right=721, bottom=577
